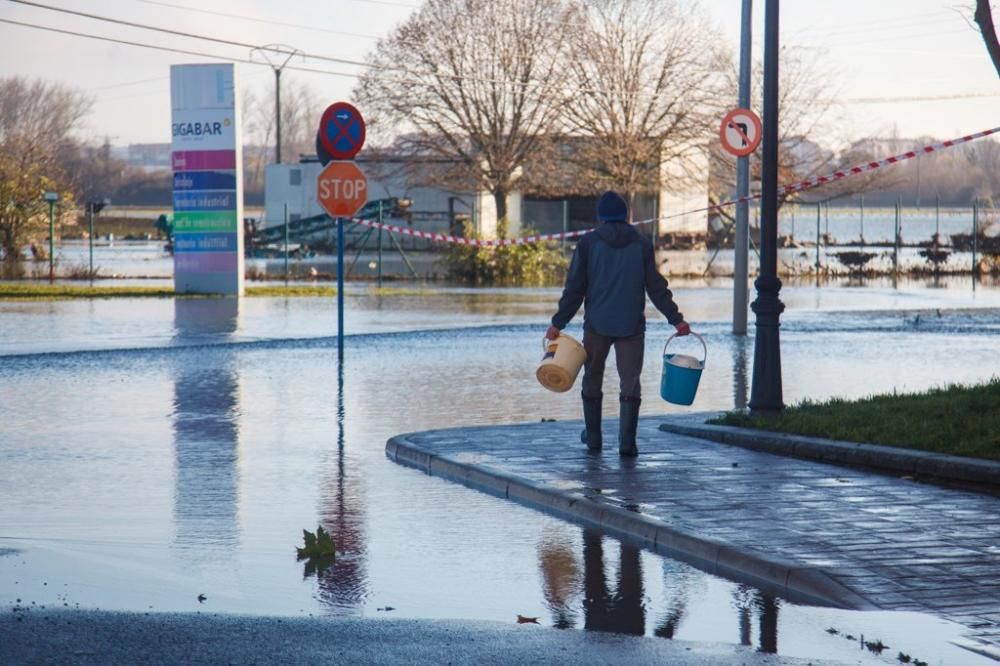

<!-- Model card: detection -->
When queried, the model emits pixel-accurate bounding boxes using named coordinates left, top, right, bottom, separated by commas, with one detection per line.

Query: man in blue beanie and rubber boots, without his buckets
left=545, top=192, right=691, bottom=456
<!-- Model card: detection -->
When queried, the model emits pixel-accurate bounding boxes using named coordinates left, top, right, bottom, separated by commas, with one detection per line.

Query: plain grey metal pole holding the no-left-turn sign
left=733, top=0, right=753, bottom=335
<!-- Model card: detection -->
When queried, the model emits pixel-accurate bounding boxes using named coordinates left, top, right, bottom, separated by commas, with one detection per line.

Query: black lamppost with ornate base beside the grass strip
left=750, top=0, right=785, bottom=416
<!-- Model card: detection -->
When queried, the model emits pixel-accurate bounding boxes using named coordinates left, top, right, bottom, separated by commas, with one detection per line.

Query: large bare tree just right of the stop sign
left=355, top=0, right=572, bottom=219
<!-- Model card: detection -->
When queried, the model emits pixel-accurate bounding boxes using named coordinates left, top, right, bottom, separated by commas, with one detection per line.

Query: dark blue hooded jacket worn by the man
left=552, top=215, right=684, bottom=338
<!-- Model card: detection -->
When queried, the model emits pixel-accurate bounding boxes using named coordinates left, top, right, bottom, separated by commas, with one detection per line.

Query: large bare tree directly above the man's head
left=564, top=0, right=725, bottom=213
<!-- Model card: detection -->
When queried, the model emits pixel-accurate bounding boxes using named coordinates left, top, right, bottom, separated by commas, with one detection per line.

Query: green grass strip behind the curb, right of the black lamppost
left=709, top=377, right=1000, bottom=460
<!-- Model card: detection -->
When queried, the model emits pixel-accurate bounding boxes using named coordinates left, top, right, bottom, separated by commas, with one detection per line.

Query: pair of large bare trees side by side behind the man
left=355, top=0, right=733, bottom=217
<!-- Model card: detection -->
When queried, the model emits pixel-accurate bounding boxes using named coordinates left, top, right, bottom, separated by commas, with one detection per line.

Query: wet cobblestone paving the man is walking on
left=396, top=417, right=1000, bottom=654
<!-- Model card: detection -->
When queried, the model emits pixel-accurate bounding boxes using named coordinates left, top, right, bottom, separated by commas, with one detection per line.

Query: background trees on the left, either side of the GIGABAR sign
left=0, top=77, right=322, bottom=262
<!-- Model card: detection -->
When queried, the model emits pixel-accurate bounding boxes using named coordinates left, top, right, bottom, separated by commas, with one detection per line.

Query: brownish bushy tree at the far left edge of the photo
left=0, top=77, right=91, bottom=262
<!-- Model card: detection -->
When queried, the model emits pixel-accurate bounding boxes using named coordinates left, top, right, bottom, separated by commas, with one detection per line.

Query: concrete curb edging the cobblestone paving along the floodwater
left=385, top=433, right=878, bottom=610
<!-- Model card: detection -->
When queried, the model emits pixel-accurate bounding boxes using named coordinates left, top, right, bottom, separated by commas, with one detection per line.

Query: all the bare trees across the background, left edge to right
left=0, top=0, right=1000, bottom=258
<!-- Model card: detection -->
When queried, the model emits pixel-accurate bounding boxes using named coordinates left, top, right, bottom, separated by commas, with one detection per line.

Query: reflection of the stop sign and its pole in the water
left=317, top=356, right=368, bottom=611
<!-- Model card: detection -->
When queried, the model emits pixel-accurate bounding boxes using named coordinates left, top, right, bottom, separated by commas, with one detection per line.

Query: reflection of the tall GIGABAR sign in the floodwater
left=172, top=298, right=239, bottom=553
